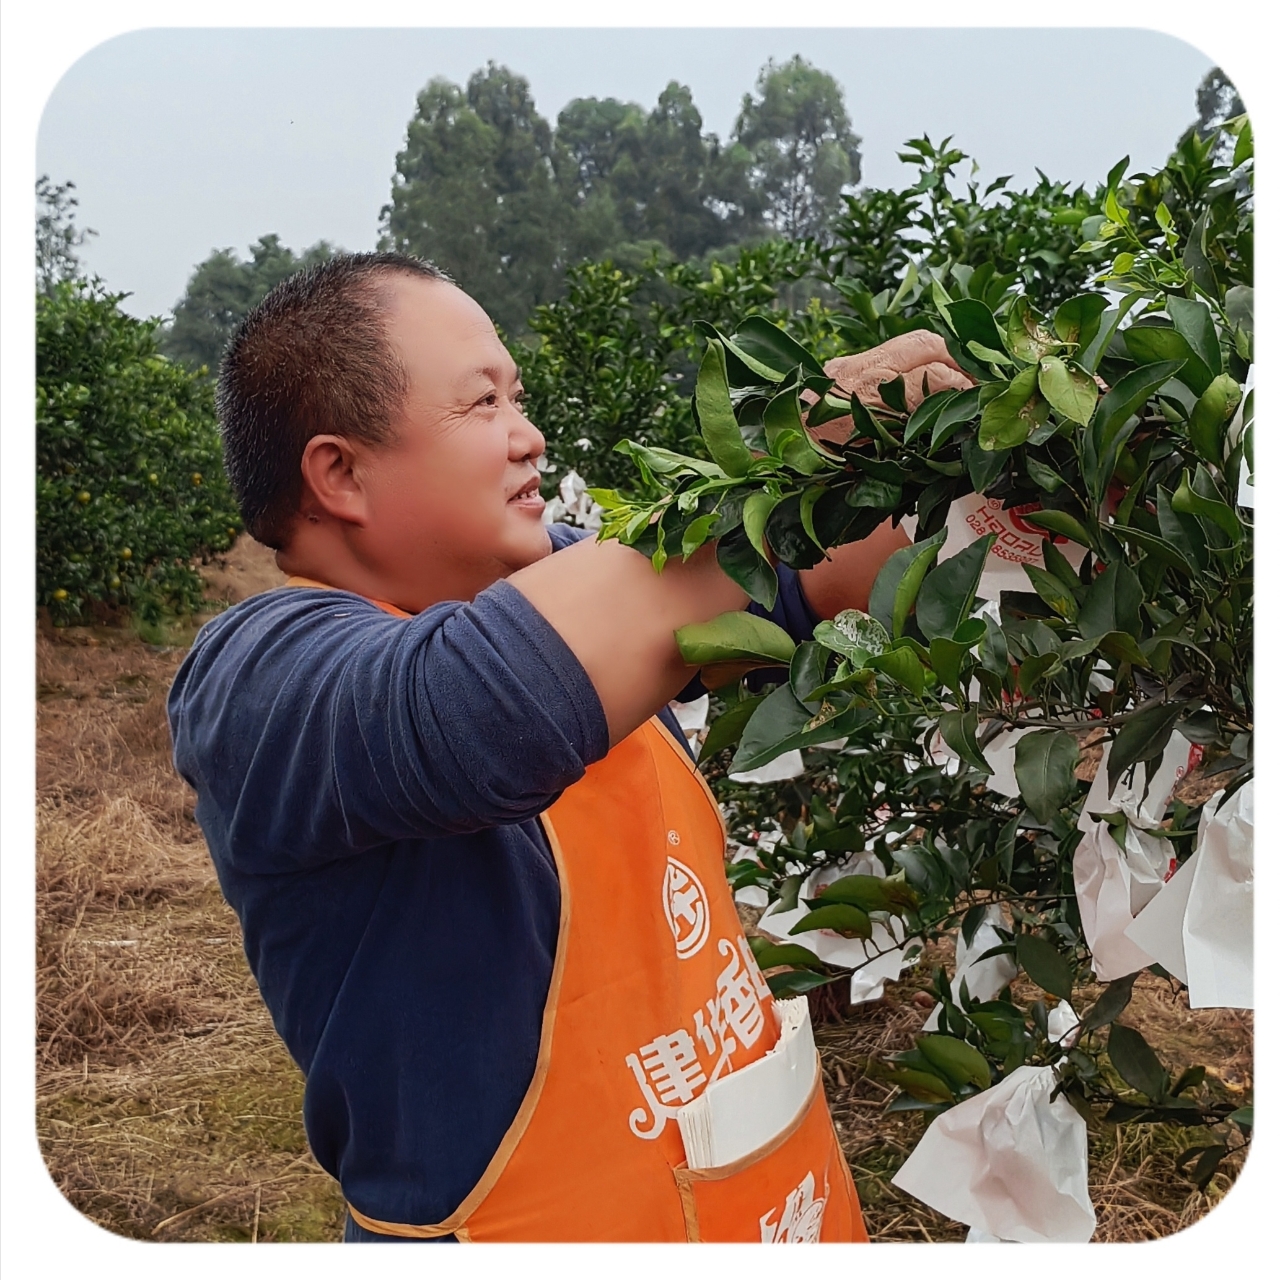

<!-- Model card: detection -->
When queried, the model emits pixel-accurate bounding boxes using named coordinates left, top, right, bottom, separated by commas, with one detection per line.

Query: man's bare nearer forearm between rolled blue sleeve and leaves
left=507, top=539, right=748, bottom=744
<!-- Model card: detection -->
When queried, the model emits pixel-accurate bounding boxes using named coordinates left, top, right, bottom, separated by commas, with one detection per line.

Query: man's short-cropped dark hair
left=218, top=253, right=452, bottom=550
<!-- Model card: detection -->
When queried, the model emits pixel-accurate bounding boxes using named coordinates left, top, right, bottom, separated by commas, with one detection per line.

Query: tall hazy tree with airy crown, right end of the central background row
left=733, top=54, right=861, bottom=239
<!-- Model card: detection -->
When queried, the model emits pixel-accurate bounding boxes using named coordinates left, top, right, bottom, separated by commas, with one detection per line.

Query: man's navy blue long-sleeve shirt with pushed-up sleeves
left=169, top=526, right=814, bottom=1234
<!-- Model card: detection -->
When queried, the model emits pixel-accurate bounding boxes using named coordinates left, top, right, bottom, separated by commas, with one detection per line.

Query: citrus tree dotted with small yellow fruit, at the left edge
left=36, top=279, right=241, bottom=625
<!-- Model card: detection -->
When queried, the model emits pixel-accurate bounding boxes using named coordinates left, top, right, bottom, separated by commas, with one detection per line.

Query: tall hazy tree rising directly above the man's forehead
left=381, top=63, right=567, bottom=330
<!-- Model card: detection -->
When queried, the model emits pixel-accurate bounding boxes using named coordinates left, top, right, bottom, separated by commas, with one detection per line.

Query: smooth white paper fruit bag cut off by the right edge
left=1125, top=778, right=1253, bottom=1009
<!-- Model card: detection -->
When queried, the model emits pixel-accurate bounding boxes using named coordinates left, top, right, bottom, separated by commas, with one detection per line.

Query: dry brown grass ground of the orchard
left=37, top=544, right=1252, bottom=1242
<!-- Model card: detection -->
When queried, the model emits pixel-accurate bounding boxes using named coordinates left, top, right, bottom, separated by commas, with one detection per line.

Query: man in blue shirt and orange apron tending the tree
left=169, top=255, right=963, bottom=1240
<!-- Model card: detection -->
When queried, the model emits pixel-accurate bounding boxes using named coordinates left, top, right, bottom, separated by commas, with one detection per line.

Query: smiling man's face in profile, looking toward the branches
left=361, top=275, right=550, bottom=608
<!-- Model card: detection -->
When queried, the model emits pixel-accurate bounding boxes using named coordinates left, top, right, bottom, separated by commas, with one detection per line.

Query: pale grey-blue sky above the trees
left=37, top=28, right=1212, bottom=315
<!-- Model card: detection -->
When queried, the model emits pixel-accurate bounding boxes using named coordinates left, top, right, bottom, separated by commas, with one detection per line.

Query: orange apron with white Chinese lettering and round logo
left=291, top=579, right=867, bottom=1242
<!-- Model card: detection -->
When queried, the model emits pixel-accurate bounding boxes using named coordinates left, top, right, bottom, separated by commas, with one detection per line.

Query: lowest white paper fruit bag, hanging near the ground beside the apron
left=893, top=1066, right=1097, bottom=1244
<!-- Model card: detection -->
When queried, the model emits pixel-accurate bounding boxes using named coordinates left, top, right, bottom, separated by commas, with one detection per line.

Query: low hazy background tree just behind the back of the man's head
left=160, top=234, right=335, bottom=371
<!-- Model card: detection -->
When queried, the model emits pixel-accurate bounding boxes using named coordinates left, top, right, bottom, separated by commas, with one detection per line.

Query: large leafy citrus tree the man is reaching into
left=594, top=116, right=1253, bottom=1185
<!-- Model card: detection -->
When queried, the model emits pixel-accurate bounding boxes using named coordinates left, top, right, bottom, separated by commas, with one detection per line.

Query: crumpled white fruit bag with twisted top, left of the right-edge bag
left=1073, top=732, right=1198, bottom=982
